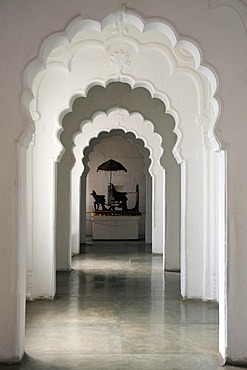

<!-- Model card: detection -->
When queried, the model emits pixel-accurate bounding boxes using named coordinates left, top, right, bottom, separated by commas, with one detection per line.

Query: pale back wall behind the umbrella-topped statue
left=86, top=136, right=146, bottom=238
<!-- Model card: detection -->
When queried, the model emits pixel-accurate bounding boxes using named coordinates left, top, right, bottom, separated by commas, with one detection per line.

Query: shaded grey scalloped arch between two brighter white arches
left=54, top=82, right=180, bottom=270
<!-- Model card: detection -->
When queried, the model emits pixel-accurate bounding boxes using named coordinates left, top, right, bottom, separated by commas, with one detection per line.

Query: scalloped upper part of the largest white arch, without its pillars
left=21, top=11, right=219, bottom=163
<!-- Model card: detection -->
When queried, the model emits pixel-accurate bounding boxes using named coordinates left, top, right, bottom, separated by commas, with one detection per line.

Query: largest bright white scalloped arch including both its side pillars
left=20, top=13, right=225, bottom=358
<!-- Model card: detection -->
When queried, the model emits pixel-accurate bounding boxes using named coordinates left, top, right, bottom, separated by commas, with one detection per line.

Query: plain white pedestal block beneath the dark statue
left=91, top=215, right=141, bottom=240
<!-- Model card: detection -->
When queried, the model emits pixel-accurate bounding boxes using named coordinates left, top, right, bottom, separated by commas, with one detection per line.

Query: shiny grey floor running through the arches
left=0, top=241, right=244, bottom=370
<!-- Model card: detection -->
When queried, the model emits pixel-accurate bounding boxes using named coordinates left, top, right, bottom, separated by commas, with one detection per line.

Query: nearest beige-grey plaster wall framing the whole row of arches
left=0, top=0, right=247, bottom=362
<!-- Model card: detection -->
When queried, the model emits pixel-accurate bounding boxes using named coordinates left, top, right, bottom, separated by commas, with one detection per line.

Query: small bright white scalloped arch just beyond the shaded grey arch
left=71, top=108, right=165, bottom=253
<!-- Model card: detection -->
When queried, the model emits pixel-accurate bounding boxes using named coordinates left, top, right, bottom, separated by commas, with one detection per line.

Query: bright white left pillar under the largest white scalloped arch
left=32, top=143, right=56, bottom=298
